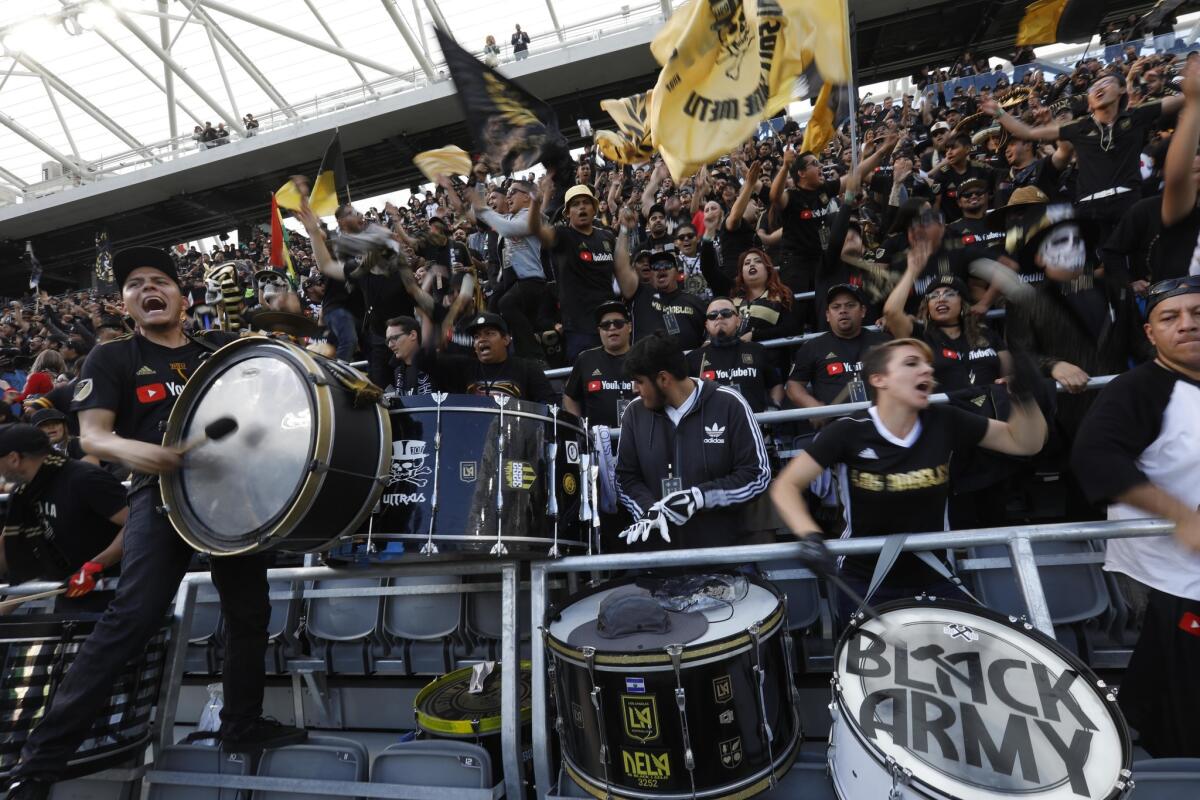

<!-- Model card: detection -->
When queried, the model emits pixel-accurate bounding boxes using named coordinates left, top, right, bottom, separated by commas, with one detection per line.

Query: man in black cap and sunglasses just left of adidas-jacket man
left=563, top=300, right=637, bottom=428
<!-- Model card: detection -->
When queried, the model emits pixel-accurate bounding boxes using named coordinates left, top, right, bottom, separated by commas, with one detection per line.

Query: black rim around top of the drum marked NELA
left=542, top=575, right=787, bottom=668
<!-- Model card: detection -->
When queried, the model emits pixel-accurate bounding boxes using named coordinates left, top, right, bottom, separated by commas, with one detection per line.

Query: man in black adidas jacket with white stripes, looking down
left=617, top=332, right=770, bottom=549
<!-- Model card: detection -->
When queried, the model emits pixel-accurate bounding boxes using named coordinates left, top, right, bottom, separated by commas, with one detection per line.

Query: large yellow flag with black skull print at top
left=649, top=0, right=851, bottom=181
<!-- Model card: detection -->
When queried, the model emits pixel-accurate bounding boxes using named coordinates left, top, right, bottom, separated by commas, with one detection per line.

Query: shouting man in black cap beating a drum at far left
left=7, top=247, right=306, bottom=798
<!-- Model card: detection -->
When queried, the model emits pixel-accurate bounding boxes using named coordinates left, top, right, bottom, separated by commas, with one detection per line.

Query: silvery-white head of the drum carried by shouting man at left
left=176, top=341, right=316, bottom=545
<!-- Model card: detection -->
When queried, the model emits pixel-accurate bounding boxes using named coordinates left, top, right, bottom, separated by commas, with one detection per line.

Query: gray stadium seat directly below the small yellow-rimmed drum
left=371, top=739, right=492, bottom=789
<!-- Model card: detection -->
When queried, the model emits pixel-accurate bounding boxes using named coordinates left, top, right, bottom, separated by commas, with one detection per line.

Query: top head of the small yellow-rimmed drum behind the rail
left=413, top=661, right=533, bottom=736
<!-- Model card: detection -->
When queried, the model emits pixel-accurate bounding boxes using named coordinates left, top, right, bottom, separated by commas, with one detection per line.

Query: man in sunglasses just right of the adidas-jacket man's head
left=688, top=297, right=784, bottom=414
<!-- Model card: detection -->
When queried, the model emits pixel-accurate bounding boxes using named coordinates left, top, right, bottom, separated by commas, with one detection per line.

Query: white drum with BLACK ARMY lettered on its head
left=829, top=600, right=1133, bottom=800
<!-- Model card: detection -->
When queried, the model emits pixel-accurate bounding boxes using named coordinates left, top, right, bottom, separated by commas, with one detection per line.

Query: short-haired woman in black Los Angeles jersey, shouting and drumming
left=770, top=338, right=1046, bottom=619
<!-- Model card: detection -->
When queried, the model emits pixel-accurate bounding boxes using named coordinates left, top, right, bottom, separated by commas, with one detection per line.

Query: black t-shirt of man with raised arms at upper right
left=1058, top=102, right=1163, bottom=200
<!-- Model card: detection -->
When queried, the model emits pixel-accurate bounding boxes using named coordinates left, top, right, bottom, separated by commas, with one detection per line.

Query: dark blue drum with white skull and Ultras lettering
left=326, top=395, right=590, bottom=565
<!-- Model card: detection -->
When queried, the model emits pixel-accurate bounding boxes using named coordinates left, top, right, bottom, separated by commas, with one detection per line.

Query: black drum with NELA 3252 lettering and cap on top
left=546, top=579, right=799, bottom=800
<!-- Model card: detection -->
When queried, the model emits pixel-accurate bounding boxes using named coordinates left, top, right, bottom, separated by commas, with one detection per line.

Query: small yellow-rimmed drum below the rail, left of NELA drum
left=413, top=661, right=533, bottom=786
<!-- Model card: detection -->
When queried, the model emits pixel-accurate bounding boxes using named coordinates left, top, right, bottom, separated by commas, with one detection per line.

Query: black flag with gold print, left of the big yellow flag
left=437, top=29, right=569, bottom=175
